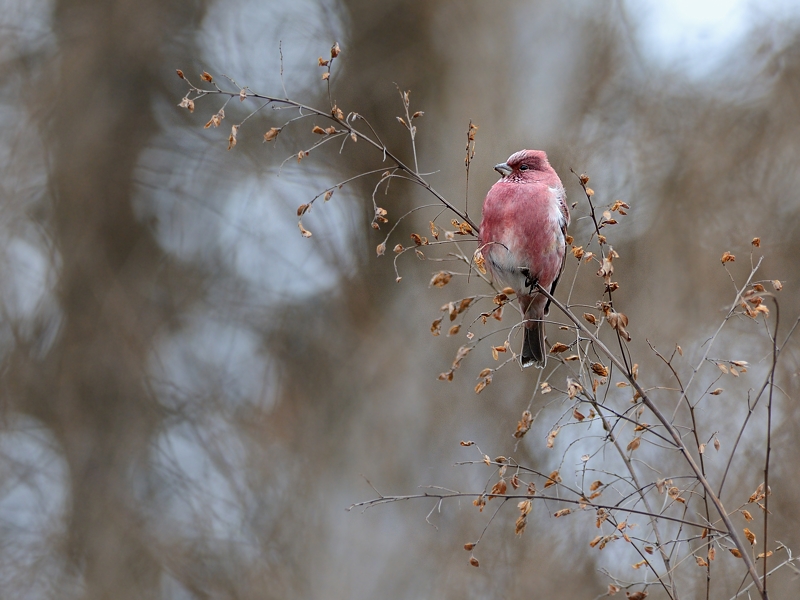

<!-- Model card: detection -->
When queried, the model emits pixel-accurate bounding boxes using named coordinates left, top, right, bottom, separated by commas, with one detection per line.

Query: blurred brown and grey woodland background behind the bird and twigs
left=0, top=0, right=800, bottom=600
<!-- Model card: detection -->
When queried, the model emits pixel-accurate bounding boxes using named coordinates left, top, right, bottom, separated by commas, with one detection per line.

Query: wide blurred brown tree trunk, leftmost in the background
left=5, top=0, right=206, bottom=599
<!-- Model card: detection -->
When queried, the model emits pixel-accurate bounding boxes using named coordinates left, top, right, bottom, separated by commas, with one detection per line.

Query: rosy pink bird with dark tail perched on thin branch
left=479, top=150, right=569, bottom=367
